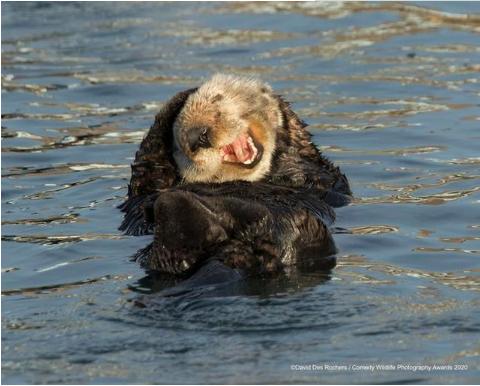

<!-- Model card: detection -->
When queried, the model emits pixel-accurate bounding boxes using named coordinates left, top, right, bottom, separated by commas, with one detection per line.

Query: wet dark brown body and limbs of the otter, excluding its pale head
left=120, top=89, right=351, bottom=274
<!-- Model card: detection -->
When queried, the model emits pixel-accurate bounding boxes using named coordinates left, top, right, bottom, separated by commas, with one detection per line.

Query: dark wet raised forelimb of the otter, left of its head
left=128, top=88, right=197, bottom=199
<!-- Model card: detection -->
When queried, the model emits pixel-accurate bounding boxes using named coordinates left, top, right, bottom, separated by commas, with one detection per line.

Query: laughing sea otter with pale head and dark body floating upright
left=120, top=74, right=352, bottom=290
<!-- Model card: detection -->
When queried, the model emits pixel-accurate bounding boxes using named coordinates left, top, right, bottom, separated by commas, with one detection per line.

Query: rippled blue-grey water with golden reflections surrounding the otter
left=2, top=3, right=480, bottom=383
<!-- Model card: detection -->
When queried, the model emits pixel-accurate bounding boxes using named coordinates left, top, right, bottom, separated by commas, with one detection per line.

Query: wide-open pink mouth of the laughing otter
left=220, top=133, right=263, bottom=168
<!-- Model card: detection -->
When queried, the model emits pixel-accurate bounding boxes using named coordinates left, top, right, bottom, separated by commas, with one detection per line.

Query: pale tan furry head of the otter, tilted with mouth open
left=173, top=74, right=283, bottom=182
